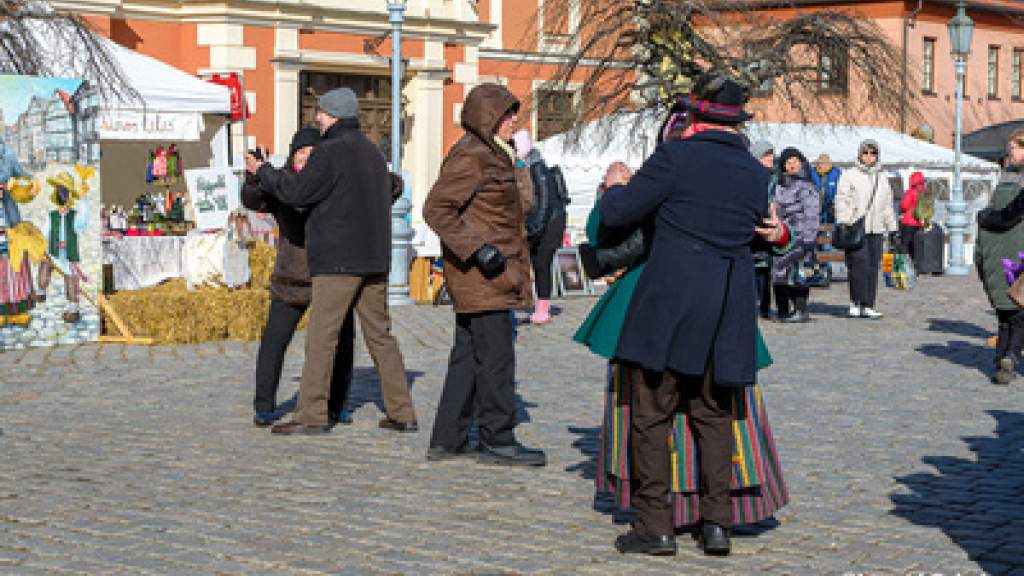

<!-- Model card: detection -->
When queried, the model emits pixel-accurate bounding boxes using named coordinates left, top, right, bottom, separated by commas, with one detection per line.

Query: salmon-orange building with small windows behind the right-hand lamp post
left=751, top=0, right=1024, bottom=148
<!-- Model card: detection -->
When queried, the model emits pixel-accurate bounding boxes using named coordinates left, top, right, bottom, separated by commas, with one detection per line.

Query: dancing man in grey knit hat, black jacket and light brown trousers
left=246, top=88, right=418, bottom=434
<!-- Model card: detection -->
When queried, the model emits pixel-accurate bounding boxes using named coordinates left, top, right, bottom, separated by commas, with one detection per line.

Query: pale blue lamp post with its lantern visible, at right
left=946, top=0, right=974, bottom=276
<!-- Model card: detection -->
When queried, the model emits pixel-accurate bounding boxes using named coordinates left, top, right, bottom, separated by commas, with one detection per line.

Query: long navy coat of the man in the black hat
left=601, top=130, right=769, bottom=386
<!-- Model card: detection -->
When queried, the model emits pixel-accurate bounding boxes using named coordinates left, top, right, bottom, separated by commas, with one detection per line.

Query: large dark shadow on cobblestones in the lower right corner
left=890, top=410, right=1024, bottom=574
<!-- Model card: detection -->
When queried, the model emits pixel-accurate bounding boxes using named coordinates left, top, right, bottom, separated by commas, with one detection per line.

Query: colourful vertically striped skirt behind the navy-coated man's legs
left=596, top=363, right=790, bottom=526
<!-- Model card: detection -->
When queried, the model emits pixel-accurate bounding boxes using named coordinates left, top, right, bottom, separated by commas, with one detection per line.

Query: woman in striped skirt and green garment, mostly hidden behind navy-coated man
left=574, top=91, right=793, bottom=553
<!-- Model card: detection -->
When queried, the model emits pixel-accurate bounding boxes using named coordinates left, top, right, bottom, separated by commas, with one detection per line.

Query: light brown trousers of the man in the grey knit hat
left=295, top=275, right=416, bottom=426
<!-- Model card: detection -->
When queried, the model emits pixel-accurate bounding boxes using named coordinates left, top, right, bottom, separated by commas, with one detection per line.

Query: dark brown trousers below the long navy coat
left=626, top=367, right=734, bottom=536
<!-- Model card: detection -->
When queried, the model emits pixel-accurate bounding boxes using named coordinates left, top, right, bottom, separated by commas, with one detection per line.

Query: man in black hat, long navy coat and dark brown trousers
left=601, top=77, right=782, bottom=554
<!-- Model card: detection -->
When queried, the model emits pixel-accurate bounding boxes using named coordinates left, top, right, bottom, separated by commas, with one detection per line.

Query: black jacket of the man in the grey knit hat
left=258, top=119, right=391, bottom=276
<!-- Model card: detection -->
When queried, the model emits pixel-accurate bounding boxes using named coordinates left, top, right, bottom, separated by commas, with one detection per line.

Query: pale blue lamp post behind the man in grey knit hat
left=387, top=0, right=415, bottom=304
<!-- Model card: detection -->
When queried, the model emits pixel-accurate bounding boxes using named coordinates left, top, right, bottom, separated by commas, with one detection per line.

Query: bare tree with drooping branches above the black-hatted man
left=535, top=0, right=912, bottom=147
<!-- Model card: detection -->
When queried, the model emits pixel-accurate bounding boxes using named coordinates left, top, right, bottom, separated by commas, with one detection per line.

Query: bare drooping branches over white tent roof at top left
left=0, top=0, right=140, bottom=102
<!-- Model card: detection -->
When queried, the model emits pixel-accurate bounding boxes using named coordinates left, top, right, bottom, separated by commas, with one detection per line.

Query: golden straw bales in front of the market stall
left=109, top=237, right=305, bottom=343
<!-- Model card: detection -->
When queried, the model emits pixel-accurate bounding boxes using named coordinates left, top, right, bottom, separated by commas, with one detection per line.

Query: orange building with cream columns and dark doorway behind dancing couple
left=61, top=0, right=593, bottom=220
